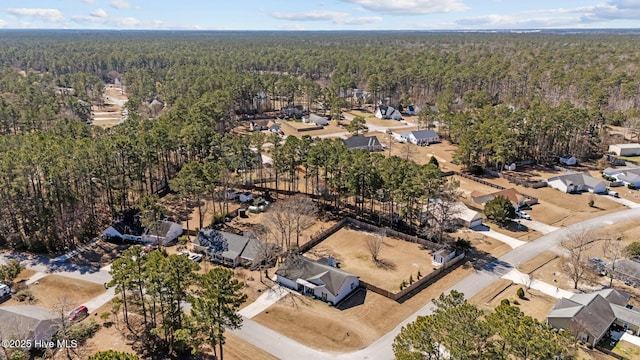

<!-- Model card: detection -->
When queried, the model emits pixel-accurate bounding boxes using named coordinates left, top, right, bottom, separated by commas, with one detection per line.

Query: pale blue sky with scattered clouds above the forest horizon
left=0, top=0, right=640, bottom=30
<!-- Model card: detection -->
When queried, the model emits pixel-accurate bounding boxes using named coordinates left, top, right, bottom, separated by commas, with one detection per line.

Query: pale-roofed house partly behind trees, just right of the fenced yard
left=420, top=199, right=484, bottom=228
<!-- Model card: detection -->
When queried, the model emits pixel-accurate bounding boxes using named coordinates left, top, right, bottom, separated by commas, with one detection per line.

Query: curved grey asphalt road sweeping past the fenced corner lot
left=232, top=208, right=640, bottom=360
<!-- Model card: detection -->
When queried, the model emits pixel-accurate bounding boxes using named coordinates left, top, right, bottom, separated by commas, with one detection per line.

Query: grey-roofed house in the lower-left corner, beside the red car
left=0, top=305, right=61, bottom=346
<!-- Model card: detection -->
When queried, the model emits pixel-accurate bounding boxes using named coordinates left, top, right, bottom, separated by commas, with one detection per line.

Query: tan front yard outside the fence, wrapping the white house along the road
left=253, top=264, right=473, bottom=351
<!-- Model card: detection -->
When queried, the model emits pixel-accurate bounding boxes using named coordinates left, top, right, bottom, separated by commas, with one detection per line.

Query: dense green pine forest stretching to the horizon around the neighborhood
left=0, top=31, right=640, bottom=251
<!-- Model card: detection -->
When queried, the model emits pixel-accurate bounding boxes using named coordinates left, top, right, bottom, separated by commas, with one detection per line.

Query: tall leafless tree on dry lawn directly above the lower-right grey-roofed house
left=562, top=228, right=595, bottom=289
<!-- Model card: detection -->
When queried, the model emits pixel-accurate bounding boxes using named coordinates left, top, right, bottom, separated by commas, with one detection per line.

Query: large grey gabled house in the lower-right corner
left=547, top=289, right=640, bottom=345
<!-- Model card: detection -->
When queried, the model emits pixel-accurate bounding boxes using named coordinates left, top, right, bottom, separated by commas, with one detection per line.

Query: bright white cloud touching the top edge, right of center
left=341, top=0, right=469, bottom=15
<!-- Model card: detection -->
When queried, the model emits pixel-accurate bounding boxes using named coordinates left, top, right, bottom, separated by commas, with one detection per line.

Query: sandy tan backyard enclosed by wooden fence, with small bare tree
left=310, top=227, right=433, bottom=291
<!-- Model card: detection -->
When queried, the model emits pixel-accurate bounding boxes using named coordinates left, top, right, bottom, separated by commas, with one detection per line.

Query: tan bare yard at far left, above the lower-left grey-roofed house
left=2, top=275, right=106, bottom=311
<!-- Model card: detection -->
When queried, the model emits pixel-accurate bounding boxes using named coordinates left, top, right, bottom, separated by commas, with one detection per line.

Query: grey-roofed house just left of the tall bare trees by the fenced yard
left=193, top=229, right=261, bottom=267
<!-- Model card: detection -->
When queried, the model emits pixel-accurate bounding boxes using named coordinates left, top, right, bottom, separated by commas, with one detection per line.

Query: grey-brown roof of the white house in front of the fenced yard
left=276, top=256, right=358, bottom=295
